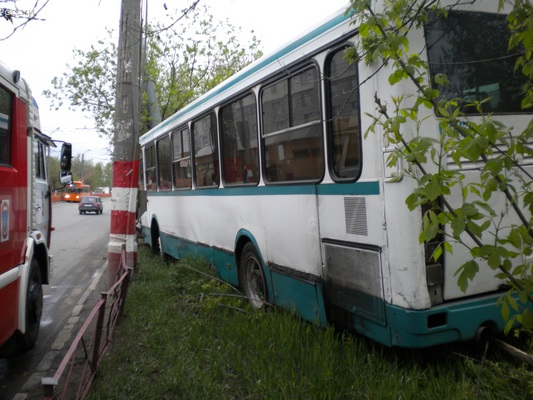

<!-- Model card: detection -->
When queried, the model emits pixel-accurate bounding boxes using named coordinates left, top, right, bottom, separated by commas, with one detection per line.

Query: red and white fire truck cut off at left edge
left=0, top=63, right=72, bottom=356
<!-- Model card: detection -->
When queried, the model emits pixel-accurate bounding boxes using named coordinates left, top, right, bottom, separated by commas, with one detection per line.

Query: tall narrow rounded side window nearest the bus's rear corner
left=326, top=48, right=361, bottom=181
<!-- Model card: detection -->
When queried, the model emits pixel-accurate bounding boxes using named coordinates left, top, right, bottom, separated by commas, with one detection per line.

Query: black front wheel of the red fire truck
left=22, top=259, right=43, bottom=350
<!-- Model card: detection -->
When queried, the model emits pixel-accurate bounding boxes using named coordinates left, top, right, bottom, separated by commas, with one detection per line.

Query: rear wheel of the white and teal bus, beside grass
left=240, top=243, right=268, bottom=310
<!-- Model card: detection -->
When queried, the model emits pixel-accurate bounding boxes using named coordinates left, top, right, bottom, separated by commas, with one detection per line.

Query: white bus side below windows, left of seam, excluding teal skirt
left=149, top=187, right=322, bottom=277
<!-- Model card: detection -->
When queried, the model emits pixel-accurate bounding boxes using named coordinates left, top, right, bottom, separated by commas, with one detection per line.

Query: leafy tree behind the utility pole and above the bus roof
left=44, top=2, right=262, bottom=139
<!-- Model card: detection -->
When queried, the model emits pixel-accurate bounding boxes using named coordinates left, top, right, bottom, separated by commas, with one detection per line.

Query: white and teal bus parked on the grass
left=140, top=1, right=531, bottom=347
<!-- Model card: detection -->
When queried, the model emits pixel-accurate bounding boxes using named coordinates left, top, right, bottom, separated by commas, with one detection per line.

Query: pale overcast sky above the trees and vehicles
left=0, top=0, right=348, bottom=162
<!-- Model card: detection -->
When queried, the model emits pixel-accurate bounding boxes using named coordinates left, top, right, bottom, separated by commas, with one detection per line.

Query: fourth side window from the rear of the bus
left=192, top=113, right=219, bottom=187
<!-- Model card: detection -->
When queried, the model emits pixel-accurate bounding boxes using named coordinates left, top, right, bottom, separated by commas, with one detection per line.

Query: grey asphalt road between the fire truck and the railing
left=0, top=198, right=111, bottom=400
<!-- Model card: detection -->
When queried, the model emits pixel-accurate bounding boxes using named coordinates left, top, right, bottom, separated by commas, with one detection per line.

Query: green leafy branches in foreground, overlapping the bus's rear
left=349, top=0, right=533, bottom=330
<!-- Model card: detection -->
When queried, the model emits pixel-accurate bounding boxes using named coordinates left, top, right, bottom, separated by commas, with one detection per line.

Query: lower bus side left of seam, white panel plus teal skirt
left=145, top=191, right=325, bottom=324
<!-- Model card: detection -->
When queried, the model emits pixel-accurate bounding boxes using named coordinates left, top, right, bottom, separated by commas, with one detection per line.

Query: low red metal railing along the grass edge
left=41, top=246, right=132, bottom=400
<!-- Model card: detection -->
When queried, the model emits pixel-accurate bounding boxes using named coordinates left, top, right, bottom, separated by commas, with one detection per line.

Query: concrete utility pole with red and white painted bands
left=107, top=0, right=141, bottom=287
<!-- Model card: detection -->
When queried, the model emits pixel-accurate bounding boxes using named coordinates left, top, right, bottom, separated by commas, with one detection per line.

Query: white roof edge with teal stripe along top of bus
left=139, top=8, right=355, bottom=145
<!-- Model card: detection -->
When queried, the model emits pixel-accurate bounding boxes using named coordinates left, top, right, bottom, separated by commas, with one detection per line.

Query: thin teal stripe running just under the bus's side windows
left=148, top=181, right=379, bottom=197
